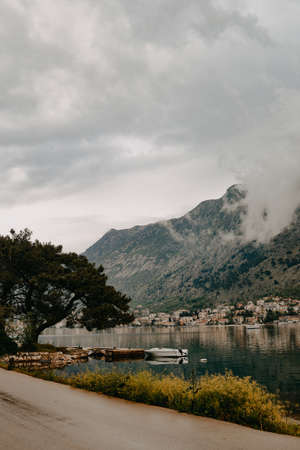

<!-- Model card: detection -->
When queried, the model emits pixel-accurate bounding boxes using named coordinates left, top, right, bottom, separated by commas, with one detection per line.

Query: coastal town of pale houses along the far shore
left=131, top=296, right=300, bottom=327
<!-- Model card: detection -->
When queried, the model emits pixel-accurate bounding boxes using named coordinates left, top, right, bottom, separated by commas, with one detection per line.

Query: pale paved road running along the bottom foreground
left=0, top=369, right=300, bottom=450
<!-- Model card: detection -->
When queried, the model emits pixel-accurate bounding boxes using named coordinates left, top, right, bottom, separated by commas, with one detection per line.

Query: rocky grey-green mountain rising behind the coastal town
left=85, top=185, right=300, bottom=310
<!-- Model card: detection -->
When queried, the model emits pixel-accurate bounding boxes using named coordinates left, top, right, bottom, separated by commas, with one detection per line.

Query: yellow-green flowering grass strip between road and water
left=24, top=371, right=300, bottom=436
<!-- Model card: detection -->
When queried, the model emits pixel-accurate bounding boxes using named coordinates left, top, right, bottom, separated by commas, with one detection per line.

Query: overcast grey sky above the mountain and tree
left=0, top=0, right=300, bottom=251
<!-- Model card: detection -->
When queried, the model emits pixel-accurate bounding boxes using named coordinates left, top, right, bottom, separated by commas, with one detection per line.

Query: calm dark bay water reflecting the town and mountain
left=40, top=324, right=300, bottom=410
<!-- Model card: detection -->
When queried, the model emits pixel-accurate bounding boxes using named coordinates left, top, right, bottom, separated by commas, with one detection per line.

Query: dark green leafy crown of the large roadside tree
left=0, top=229, right=133, bottom=343
